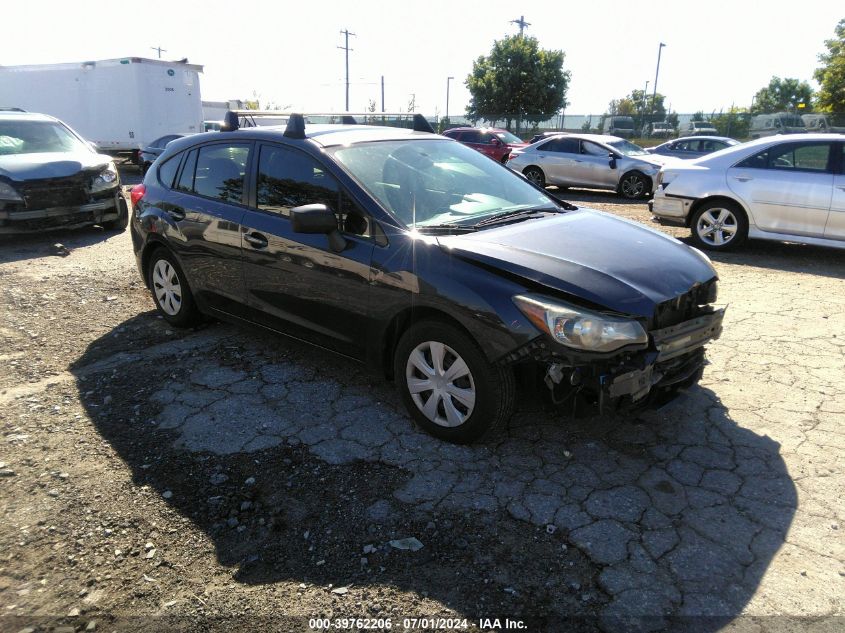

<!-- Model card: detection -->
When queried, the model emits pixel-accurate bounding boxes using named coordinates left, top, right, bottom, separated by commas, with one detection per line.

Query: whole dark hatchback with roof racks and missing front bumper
left=131, top=113, right=723, bottom=442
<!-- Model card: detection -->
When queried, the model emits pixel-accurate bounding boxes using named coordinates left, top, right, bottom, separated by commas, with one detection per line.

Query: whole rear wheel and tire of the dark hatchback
left=147, top=248, right=200, bottom=327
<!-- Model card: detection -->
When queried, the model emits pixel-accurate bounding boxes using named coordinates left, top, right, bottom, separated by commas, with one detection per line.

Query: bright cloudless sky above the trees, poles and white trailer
left=0, top=0, right=845, bottom=116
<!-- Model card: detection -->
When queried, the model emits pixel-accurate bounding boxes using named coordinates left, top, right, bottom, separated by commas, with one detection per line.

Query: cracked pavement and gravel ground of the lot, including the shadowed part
left=0, top=178, right=845, bottom=631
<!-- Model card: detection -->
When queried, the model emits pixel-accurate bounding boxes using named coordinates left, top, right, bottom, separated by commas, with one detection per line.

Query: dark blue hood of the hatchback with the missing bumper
left=438, top=209, right=716, bottom=318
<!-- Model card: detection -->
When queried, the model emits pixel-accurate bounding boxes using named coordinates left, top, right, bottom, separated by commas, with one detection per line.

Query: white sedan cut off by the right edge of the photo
left=649, top=134, right=845, bottom=250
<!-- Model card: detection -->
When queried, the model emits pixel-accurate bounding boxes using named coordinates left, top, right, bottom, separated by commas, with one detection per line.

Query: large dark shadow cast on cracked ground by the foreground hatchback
left=71, top=315, right=797, bottom=631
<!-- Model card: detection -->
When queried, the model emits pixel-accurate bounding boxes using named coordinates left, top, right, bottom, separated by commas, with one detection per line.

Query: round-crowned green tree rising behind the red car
left=465, top=35, right=570, bottom=130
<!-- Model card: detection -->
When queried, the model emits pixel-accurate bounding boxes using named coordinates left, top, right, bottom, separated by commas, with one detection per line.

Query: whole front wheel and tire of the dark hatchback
left=394, top=321, right=516, bottom=444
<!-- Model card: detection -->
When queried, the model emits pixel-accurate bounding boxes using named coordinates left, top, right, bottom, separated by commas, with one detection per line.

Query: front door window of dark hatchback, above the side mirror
left=256, top=145, right=340, bottom=217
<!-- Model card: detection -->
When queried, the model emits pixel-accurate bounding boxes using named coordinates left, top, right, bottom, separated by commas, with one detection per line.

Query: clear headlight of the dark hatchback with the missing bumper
left=513, top=295, right=648, bottom=352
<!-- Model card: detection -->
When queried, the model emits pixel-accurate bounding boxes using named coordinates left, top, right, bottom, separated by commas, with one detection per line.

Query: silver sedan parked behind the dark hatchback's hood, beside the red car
left=507, top=134, right=678, bottom=199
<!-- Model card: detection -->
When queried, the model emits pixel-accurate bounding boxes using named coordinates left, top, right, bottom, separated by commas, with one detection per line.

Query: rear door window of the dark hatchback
left=194, top=143, right=249, bottom=203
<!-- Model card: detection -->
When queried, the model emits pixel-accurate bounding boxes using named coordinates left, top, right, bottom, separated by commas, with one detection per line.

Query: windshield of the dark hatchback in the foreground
left=334, top=140, right=560, bottom=228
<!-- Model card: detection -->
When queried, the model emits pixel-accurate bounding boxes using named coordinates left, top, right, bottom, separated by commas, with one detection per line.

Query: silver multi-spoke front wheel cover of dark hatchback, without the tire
left=405, top=341, right=476, bottom=427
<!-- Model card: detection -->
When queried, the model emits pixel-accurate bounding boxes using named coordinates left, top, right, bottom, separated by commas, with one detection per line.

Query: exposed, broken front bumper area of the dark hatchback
left=520, top=308, right=725, bottom=413
